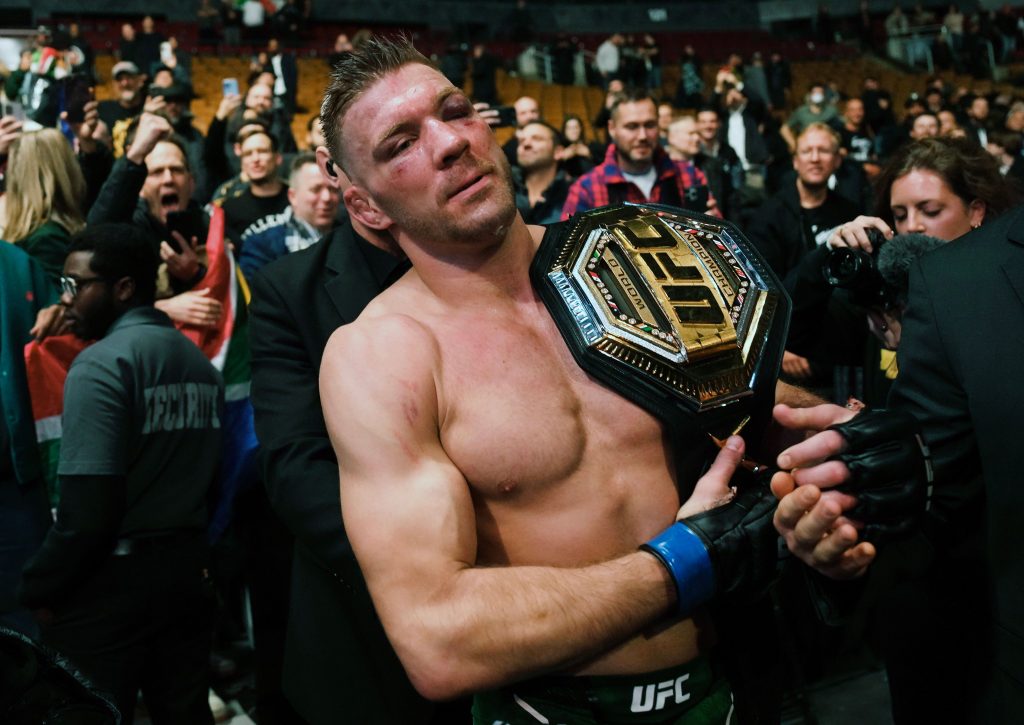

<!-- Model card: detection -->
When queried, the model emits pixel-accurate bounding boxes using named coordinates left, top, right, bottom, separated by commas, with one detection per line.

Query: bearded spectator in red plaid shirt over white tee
left=562, top=90, right=721, bottom=219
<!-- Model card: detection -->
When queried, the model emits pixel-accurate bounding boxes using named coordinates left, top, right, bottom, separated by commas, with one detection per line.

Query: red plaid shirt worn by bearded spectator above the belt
left=562, top=143, right=722, bottom=221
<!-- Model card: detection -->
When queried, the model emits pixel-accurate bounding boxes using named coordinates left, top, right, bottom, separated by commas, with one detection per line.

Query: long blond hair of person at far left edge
left=4, top=128, right=85, bottom=242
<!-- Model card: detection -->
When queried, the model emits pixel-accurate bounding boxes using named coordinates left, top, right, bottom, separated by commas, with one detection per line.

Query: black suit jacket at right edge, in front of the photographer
left=890, top=207, right=1024, bottom=723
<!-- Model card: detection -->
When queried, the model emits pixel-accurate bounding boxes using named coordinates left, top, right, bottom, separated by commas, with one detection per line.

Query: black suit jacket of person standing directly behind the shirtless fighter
left=250, top=219, right=432, bottom=725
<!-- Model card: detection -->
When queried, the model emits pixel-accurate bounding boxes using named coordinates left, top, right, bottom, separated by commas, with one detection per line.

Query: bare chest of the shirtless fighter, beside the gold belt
left=438, top=319, right=664, bottom=495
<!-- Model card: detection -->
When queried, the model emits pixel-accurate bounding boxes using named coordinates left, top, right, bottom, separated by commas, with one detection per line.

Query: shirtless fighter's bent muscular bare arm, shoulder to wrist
left=321, top=317, right=742, bottom=698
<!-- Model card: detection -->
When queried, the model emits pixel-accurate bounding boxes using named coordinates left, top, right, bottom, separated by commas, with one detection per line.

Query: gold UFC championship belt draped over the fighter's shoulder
left=530, top=204, right=790, bottom=479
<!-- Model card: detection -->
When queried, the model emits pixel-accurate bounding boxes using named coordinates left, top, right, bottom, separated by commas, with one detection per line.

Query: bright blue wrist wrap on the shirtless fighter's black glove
left=640, top=521, right=715, bottom=616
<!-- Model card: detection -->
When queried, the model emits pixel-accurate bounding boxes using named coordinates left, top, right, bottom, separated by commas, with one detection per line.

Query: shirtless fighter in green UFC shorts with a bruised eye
left=317, top=36, right=776, bottom=724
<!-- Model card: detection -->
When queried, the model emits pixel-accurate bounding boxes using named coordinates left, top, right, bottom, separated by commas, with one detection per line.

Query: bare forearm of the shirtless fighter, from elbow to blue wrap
left=378, top=552, right=676, bottom=699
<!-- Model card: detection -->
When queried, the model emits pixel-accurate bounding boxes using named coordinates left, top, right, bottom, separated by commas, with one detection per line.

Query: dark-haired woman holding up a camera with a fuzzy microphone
left=786, top=138, right=1017, bottom=404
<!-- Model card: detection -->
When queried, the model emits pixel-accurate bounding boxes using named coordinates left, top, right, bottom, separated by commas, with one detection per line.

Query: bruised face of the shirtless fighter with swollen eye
left=341, top=63, right=516, bottom=251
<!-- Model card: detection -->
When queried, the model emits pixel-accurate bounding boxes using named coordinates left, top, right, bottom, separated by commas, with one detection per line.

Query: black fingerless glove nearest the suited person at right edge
left=829, top=410, right=932, bottom=543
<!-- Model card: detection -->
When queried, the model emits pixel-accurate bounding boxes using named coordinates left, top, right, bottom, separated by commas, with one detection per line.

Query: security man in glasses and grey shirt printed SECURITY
left=19, top=224, right=224, bottom=725
